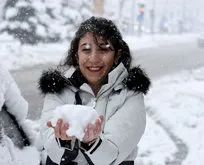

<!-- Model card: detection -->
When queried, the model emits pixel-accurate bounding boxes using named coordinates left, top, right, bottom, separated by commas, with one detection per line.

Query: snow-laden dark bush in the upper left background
left=0, top=0, right=92, bottom=44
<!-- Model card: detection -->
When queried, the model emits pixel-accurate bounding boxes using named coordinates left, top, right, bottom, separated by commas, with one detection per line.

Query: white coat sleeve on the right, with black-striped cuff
left=80, top=92, right=146, bottom=165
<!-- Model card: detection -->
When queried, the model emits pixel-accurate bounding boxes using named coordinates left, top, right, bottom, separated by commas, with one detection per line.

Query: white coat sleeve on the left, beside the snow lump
left=40, top=94, right=77, bottom=164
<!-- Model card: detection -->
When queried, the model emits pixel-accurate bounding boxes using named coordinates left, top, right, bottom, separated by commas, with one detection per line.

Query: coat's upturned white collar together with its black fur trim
left=38, top=63, right=151, bottom=94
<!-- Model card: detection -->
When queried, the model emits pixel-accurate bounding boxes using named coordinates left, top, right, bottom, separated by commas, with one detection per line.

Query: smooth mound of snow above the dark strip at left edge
left=4, top=67, right=28, bottom=123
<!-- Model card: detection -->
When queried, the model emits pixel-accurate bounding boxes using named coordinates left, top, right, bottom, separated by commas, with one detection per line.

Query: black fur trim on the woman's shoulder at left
left=38, top=69, right=71, bottom=94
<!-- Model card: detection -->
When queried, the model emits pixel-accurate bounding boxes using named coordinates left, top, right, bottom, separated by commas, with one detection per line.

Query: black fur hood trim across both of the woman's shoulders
left=38, top=66, right=151, bottom=94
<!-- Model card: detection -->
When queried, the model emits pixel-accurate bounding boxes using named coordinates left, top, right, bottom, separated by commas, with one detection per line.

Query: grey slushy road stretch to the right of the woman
left=134, top=42, right=204, bottom=79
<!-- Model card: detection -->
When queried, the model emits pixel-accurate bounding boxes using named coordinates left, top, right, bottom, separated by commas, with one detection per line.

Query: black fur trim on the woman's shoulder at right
left=123, top=67, right=151, bottom=94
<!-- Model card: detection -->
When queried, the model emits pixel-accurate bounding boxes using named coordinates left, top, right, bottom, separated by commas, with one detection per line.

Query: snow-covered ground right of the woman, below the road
left=135, top=68, right=204, bottom=165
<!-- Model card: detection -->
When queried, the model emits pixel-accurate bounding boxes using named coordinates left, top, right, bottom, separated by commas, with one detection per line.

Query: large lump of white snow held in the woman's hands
left=51, top=104, right=99, bottom=140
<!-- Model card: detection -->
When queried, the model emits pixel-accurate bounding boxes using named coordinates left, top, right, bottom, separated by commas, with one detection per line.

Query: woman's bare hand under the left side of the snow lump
left=47, top=119, right=75, bottom=140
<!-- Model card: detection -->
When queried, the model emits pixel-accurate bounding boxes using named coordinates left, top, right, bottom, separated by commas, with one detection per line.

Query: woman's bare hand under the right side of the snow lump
left=83, top=115, right=104, bottom=143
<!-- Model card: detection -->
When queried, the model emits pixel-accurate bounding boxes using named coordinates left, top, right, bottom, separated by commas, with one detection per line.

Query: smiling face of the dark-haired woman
left=78, top=32, right=115, bottom=87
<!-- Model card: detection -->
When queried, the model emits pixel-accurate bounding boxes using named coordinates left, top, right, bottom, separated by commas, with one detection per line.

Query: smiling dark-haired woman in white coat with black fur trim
left=39, top=17, right=150, bottom=165
